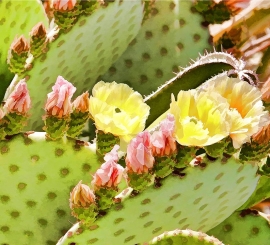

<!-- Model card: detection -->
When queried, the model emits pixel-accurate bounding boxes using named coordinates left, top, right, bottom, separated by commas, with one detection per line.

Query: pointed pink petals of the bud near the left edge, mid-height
left=4, top=79, right=31, bottom=115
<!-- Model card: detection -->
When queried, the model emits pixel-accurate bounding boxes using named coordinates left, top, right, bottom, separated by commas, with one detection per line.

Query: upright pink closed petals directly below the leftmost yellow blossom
left=126, top=131, right=155, bottom=174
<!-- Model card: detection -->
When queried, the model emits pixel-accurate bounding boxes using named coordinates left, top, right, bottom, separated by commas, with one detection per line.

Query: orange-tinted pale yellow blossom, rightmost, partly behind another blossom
left=205, top=77, right=269, bottom=149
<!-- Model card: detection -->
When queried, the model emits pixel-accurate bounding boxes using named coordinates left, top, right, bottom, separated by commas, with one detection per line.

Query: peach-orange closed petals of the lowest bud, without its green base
left=69, top=181, right=96, bottom=209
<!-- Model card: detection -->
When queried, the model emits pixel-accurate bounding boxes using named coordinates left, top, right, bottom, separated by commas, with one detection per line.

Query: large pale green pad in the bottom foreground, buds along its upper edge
left=57, top=155, right=258, bottom=245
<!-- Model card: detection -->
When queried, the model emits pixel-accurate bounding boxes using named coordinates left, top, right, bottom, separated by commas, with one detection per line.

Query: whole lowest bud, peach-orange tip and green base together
left=69, top=181, right=98, bottom=226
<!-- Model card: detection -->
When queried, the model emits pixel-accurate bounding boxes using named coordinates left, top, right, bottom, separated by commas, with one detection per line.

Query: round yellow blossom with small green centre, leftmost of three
left=90, top=81, right=150, bottom=142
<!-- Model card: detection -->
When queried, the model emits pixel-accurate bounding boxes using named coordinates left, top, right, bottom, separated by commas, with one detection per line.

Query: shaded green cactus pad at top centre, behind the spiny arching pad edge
left=102, top=0, right=210, bottom=95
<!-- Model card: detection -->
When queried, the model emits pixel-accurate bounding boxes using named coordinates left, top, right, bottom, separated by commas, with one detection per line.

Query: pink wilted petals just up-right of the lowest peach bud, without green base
left=92, top=145, right=124, bottom=188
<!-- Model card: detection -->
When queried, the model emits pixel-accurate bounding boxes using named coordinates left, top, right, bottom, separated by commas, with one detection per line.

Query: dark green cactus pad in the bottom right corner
left=207, top=211, right=270, bottom=245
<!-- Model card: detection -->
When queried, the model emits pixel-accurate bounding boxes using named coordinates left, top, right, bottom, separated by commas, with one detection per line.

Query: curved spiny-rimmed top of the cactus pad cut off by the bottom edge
left=147, top=230, right=224, bottom=245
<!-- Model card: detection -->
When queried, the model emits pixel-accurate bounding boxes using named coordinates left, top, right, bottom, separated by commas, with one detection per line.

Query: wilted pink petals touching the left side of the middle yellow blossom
left=151, top=114, right=176, bottom=156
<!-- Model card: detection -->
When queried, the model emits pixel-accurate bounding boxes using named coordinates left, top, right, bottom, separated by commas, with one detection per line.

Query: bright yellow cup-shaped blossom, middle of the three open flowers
left=169, top=90, right=229, bottom=147
